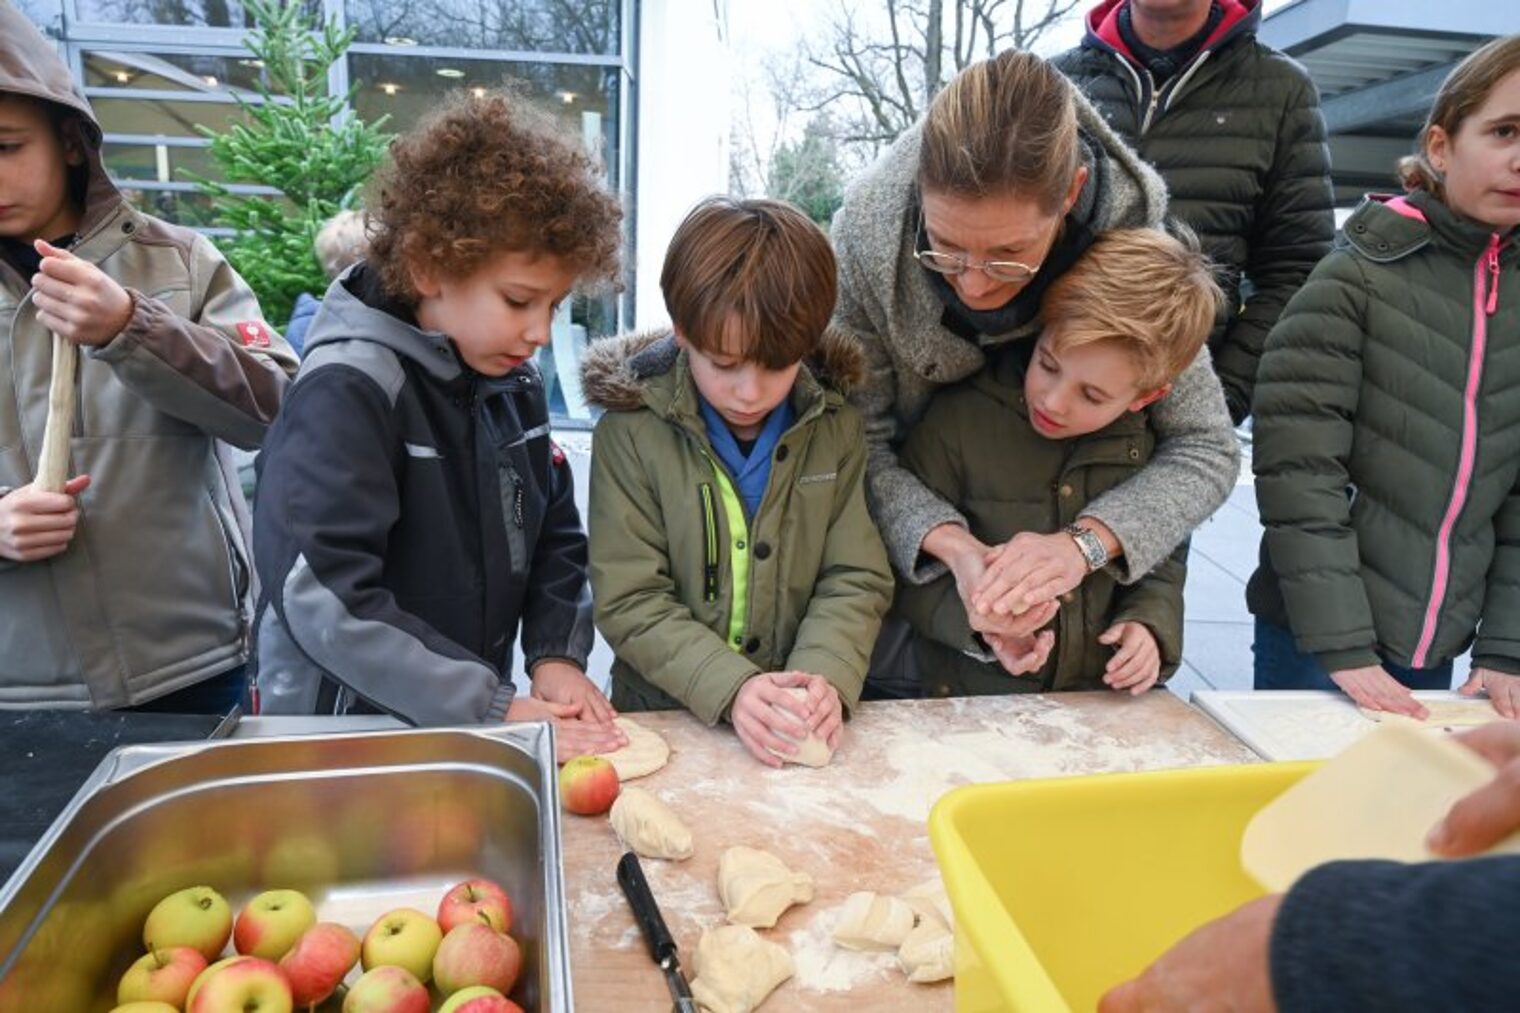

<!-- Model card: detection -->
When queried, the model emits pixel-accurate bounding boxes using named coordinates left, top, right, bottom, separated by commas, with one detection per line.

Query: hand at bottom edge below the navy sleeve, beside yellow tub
left=1097, top=894, right=1283, bottom=1013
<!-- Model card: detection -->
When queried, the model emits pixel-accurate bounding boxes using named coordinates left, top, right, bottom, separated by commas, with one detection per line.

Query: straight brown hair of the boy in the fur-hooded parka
left=660, top=196, right=838, bottom=370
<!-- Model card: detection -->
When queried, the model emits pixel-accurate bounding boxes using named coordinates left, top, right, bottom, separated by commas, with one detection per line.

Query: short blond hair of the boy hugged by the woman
left=1040, top=225, right=1224, bottom=391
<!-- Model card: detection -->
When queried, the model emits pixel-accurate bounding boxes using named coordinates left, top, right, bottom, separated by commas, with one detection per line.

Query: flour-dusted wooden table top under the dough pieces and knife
left=562, top=691, right=1257, bottom=1013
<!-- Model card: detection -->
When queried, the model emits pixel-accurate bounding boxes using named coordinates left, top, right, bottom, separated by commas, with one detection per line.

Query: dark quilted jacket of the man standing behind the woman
left=1053, top=0, right=1335, bottom=423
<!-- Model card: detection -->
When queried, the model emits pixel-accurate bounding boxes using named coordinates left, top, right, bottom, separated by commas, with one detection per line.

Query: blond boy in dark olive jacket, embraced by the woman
left=897, top=228, right=1219, bottom=697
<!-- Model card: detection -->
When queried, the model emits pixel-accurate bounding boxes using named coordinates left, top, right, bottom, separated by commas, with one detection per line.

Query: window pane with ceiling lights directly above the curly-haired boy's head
left=348, top=53, right=617, bottom=179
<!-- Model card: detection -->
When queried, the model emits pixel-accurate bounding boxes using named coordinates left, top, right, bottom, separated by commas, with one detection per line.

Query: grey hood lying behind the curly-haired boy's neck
left=306, top=262, right=465, bottom=383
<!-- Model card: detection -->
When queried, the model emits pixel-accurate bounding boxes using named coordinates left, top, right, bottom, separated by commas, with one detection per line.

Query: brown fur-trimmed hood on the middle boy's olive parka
left=581, top=327, right=865, bottom=412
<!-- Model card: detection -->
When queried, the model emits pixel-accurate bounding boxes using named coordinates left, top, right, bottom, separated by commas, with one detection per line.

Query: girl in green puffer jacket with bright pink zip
left=1246, top=35, right=1520, bottom=718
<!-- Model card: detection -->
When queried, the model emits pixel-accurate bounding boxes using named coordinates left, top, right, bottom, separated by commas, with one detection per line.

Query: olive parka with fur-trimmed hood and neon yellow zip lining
left=582, top=332, right=892, bottom=724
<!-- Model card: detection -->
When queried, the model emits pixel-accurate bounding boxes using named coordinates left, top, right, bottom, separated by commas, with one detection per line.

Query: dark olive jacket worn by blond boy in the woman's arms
left=895, top=342, right=1186, bottom=695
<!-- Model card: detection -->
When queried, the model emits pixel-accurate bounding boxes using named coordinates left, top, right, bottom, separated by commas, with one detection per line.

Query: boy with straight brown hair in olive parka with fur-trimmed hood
left=584, top=198, right=892, bottom=767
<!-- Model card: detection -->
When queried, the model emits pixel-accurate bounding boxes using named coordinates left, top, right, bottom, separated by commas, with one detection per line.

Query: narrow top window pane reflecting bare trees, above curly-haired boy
left=348, top=0, right=620, bottom=56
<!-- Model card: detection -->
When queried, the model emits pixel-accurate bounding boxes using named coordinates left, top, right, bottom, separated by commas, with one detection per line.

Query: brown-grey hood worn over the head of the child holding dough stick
left=0, top=0, right=122, bottom=236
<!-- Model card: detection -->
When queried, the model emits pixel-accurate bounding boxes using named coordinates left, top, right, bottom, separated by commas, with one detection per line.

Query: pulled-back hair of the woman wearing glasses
left=918, top=50, right=1082, bottom=213
